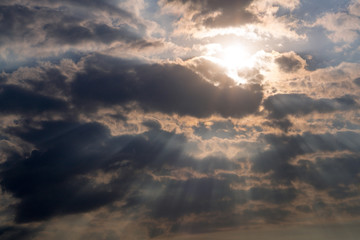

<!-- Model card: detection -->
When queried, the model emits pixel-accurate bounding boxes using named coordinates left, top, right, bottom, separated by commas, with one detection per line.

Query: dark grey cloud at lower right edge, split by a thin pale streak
left=252, top=132, right=360, bottom=191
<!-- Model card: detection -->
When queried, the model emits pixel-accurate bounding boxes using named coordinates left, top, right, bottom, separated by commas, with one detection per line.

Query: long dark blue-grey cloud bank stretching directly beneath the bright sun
left=72, top=56, right=262, bottom=117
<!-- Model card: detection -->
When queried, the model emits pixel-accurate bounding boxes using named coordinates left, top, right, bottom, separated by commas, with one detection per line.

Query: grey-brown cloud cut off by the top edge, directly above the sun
left=167, top=0, right=257, bottom=27
